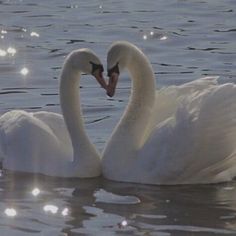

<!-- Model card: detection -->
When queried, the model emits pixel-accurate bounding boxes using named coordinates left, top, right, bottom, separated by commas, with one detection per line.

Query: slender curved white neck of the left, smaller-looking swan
left=60, top=65, right=94, bottom=161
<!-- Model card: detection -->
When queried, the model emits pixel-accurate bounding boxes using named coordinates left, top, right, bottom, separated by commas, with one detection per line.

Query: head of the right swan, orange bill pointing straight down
left=107, top=41, right=134, bottom=97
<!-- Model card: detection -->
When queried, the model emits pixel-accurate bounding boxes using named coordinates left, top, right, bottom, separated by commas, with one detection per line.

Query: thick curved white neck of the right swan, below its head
left=114, top=47, right=156, bottom=148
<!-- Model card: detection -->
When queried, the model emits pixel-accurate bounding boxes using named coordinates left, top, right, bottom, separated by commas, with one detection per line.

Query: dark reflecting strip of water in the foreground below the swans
left=0, top=172, right=236, bottom=235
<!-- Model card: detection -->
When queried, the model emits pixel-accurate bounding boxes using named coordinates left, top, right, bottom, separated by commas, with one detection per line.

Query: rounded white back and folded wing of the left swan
left=0, top=110, right=73, bottom=173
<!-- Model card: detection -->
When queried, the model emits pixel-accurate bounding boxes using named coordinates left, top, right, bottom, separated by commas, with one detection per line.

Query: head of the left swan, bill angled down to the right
left=66, top=48, right=107, bottom=89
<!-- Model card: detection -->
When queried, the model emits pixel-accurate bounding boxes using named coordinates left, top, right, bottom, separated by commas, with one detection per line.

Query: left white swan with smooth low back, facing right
left=0, top=49, right=106, bottom=178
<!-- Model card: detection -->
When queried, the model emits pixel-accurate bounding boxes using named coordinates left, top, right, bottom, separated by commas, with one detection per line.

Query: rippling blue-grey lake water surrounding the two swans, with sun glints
left=0, top=0, right=236, bottom=236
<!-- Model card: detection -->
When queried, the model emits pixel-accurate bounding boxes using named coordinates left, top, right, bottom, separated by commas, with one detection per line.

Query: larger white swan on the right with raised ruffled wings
left=102, top=41, right=236, bottom=185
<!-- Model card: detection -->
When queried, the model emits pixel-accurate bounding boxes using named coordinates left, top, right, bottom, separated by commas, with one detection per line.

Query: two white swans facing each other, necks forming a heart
left=0, top=42, right=236, bottom=185
